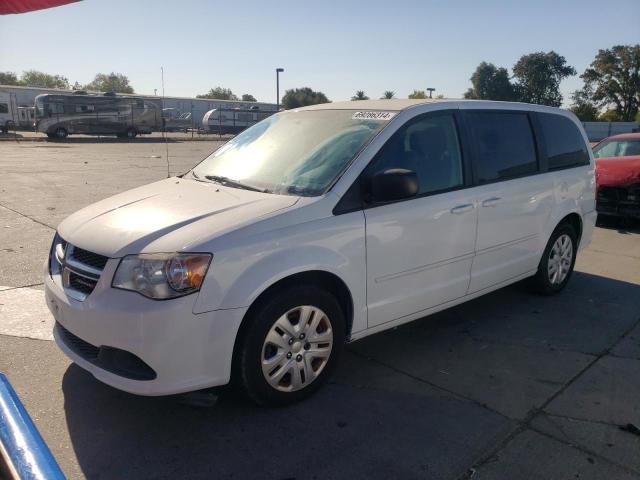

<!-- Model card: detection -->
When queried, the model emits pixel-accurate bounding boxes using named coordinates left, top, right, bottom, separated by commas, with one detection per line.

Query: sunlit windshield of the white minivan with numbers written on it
left=192, top=110, right=392, bottom=196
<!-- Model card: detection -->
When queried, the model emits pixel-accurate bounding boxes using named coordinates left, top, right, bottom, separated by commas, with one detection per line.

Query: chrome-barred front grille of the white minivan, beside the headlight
left=49, top=234, right=109, bottom=301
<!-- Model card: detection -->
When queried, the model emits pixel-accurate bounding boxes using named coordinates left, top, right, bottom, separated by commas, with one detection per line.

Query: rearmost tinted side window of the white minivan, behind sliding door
left=538, top=113, right=589, bottom=170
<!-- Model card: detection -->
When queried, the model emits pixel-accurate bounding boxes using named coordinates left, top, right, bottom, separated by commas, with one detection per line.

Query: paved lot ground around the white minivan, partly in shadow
left=0, top=139, right=640, bottom=480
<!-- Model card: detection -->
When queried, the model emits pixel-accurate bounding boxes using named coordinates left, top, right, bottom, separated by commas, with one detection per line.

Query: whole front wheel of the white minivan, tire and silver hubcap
left=235, top=286, right=345, bottom=406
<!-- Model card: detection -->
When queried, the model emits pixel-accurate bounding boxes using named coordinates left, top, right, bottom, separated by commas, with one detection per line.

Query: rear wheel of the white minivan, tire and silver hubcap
left=532, top=224, right=578, bottom=295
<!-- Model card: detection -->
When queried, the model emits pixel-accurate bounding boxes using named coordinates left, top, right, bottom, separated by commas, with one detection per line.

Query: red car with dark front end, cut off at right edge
left=593, top=133, right=640, bottom=218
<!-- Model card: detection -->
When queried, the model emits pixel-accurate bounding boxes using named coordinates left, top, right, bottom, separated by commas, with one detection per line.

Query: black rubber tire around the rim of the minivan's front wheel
left=233, top=285, right=345, bottom=406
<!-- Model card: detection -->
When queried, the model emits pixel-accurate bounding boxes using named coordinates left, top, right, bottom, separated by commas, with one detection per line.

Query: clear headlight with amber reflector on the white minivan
left=111, top=253, right=212, bottom=300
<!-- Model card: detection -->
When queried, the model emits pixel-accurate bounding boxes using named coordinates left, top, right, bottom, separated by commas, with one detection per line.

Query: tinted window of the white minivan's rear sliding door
left=466, top=112, right=538, bottom=183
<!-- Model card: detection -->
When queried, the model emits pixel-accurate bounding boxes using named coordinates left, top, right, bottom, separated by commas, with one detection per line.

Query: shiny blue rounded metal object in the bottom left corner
left=0, top=373, right=65, bottom=480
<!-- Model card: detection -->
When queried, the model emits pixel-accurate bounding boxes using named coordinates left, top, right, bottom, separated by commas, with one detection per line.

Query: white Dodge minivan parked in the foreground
left=45, top=100, right=596, bottom=405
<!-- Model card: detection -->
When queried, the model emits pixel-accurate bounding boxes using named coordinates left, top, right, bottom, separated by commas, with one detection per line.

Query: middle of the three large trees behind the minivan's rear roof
left=513, top=50, right=576, bottom=107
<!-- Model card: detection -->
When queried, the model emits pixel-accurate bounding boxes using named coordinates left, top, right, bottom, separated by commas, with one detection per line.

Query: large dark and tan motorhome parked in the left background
left=35, top=92, right=162, bottom=139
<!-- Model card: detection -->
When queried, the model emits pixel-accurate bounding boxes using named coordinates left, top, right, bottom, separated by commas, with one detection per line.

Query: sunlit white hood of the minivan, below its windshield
left=58, top=178, right=299, bottom=258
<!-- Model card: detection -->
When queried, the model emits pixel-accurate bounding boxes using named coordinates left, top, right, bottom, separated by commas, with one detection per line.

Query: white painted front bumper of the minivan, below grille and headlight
left=45, top=260, right=246, bottom=395
